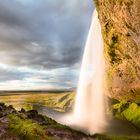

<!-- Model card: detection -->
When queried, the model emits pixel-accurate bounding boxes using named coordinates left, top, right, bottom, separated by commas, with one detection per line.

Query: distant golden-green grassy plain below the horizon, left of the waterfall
left=0, top=92, right=75, bottom=112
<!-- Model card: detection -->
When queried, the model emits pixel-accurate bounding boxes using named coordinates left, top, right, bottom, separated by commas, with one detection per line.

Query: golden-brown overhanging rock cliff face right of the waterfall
left=94, top=0, right=140, bottom=100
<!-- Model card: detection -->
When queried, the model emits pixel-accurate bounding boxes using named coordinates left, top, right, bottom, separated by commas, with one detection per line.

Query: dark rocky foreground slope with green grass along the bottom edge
left=0, top=103, right=140, bottom=140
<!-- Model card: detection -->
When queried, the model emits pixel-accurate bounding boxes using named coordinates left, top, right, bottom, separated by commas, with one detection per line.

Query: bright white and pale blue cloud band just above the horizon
left=0, top=64, right=79, bottom=90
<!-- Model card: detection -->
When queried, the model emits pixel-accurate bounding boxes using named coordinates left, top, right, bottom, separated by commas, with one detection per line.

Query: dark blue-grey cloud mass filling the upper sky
left=0, top=0, right=91, bottom=68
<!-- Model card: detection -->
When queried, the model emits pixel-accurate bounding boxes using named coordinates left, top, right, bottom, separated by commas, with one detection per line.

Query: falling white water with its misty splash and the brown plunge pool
left=42, top=10, right=139, bottom=136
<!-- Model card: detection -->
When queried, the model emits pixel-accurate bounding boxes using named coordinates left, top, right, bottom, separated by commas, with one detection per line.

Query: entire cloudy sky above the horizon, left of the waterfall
left=0, top=0, right=94, bottom=90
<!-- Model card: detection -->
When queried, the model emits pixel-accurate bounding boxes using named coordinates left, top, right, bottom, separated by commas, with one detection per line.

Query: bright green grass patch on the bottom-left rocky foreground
left=8, top=114, right=51, bottom=140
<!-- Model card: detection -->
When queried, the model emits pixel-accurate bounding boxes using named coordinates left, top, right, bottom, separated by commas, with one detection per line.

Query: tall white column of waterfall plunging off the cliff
left=73, top=10, right=106, bottom=133
